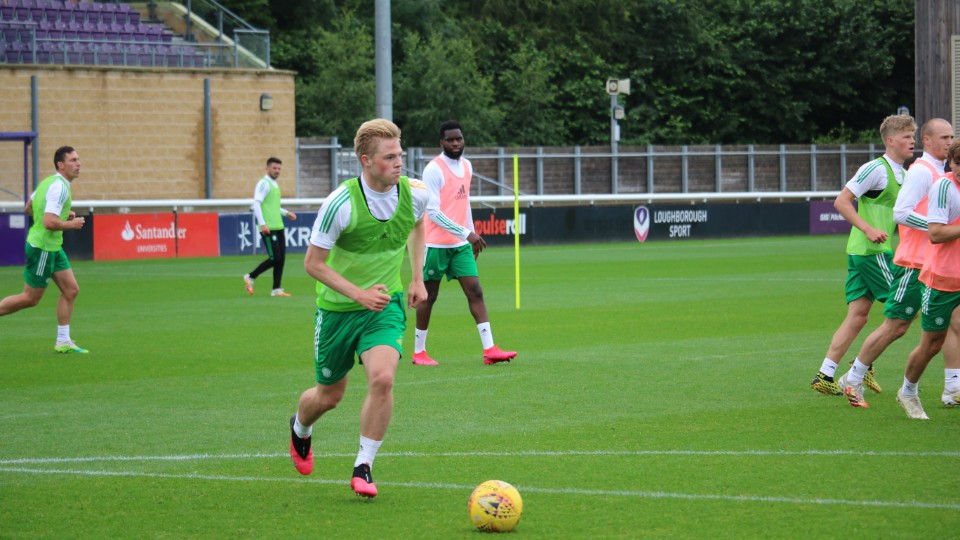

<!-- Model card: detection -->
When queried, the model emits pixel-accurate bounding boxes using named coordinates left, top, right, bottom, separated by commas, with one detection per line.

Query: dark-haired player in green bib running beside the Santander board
left=0, top=146, right=89, bottom=353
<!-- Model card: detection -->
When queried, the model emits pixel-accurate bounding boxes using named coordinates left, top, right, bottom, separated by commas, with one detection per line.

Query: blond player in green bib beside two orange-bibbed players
left=810, top=115, right=917, bottom=395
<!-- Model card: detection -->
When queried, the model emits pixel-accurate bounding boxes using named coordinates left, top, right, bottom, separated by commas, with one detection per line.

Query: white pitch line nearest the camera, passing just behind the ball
left=0, top=468, right=960, bottom=510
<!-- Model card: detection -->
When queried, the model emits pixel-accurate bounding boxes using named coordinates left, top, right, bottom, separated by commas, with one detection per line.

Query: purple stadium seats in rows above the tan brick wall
left=0, top=0, right=209, bottom=68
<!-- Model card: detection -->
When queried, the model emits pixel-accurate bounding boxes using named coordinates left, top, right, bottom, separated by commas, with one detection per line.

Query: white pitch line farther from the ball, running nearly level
left=0, top=450, right=960, bottom=465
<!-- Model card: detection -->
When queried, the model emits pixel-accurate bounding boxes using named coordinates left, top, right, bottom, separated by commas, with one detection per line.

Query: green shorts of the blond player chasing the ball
left=313, top=293, right=407, bottom=384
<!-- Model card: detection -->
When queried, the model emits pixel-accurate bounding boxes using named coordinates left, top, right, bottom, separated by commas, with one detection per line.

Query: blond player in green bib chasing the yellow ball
left=290, top=119, right=429, bottom=497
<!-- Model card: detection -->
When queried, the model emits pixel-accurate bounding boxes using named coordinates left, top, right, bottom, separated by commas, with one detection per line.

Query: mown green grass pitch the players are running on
left=0, top=236, right=960, bottom=538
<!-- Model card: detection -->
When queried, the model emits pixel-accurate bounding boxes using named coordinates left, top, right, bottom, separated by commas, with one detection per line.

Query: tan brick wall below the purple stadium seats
left=0, top=66, right=296, bottom=201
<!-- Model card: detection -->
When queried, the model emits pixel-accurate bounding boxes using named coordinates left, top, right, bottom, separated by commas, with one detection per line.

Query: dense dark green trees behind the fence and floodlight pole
left=228, top=0, right=914, bottom=146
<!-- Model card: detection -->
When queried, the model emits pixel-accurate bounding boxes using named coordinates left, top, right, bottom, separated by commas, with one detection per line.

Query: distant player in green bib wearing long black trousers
left=243, top=157, right=297, bottom=296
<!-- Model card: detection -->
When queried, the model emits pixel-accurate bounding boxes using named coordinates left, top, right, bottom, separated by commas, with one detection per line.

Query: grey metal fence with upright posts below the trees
left=296, top=138, right=883, bottom=197
